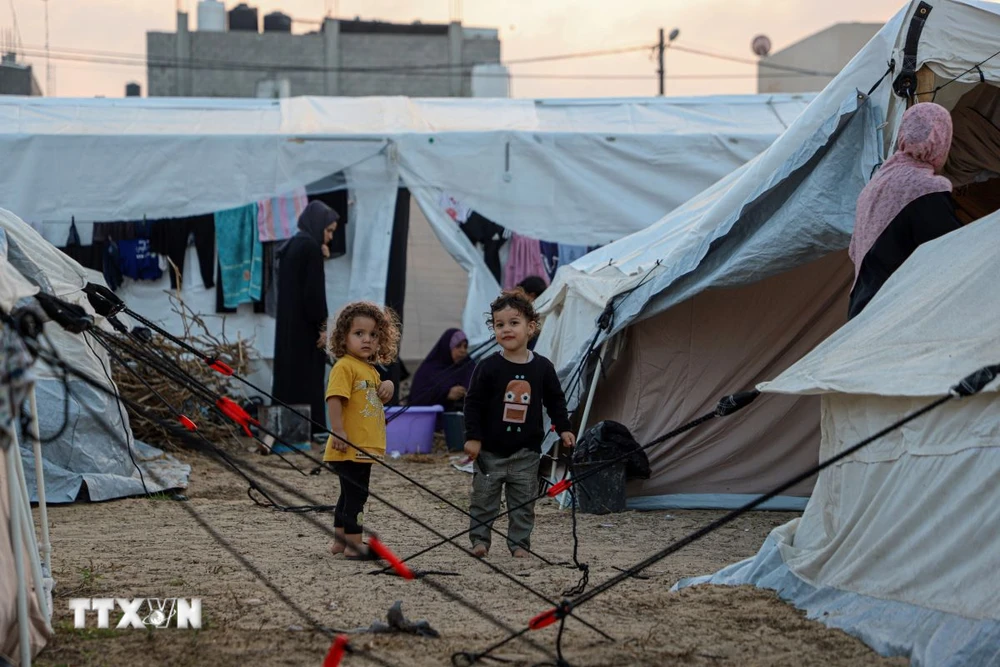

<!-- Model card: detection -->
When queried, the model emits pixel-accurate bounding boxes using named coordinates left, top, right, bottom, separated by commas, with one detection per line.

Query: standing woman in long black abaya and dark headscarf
left=272, top=201, right=339, bottom=435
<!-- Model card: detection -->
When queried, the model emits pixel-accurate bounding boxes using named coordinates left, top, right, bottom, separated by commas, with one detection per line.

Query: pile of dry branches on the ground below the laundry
left=111, top=293, right=256, bottom=448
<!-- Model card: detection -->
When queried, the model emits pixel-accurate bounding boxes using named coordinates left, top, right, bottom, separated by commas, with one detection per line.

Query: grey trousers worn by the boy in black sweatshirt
left=469, top=449, right=541, bottom=552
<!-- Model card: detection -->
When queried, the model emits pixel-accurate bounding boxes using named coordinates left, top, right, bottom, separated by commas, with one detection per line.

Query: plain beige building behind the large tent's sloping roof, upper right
left=757, top=23, right=882, bottom=93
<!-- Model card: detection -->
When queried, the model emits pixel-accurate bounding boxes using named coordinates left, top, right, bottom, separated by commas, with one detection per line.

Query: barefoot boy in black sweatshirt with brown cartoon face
left=465, top=289, right=576, bottom=558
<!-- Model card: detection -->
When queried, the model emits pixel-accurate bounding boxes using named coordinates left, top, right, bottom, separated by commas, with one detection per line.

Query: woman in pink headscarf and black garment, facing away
left=848, top=102, right=962, bottom=319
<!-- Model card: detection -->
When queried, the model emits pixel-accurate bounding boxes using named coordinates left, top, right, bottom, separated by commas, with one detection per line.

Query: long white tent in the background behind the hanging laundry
left=0, top=95, right=811, bottom=368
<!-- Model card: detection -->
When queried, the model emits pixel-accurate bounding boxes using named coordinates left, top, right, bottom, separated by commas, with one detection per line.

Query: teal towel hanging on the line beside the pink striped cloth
left=215, top=203, right=264, bottom=308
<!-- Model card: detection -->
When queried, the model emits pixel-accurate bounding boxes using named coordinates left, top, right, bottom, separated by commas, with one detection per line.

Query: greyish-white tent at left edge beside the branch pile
left=0, top=209, right=190, bottom=503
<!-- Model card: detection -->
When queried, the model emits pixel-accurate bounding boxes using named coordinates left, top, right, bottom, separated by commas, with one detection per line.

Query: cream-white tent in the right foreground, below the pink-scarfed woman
left=682, top=214, right=1000, bottom=666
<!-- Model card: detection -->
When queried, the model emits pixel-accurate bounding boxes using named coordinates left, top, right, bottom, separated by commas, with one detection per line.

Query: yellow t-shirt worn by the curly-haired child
left=323, top=355, right=385, bottom=463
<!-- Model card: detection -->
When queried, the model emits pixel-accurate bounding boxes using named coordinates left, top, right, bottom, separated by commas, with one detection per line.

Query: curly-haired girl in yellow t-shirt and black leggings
left=323, top=301, right=399, bottom=560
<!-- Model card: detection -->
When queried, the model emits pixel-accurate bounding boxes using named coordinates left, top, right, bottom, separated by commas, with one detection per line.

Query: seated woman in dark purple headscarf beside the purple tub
left=409, top=329, right=476, bottom=412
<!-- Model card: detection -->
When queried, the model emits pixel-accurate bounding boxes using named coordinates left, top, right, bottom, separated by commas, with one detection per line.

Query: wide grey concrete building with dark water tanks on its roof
left=146, top=9, right=500, bottom=97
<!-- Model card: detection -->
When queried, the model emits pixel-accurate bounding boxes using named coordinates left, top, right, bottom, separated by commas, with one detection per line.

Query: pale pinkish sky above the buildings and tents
left=7, top=0, right=905, bottom=97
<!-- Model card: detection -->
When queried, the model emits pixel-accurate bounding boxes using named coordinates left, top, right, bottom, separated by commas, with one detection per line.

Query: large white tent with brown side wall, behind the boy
left=536, top=0, right=1000, bottom=508
